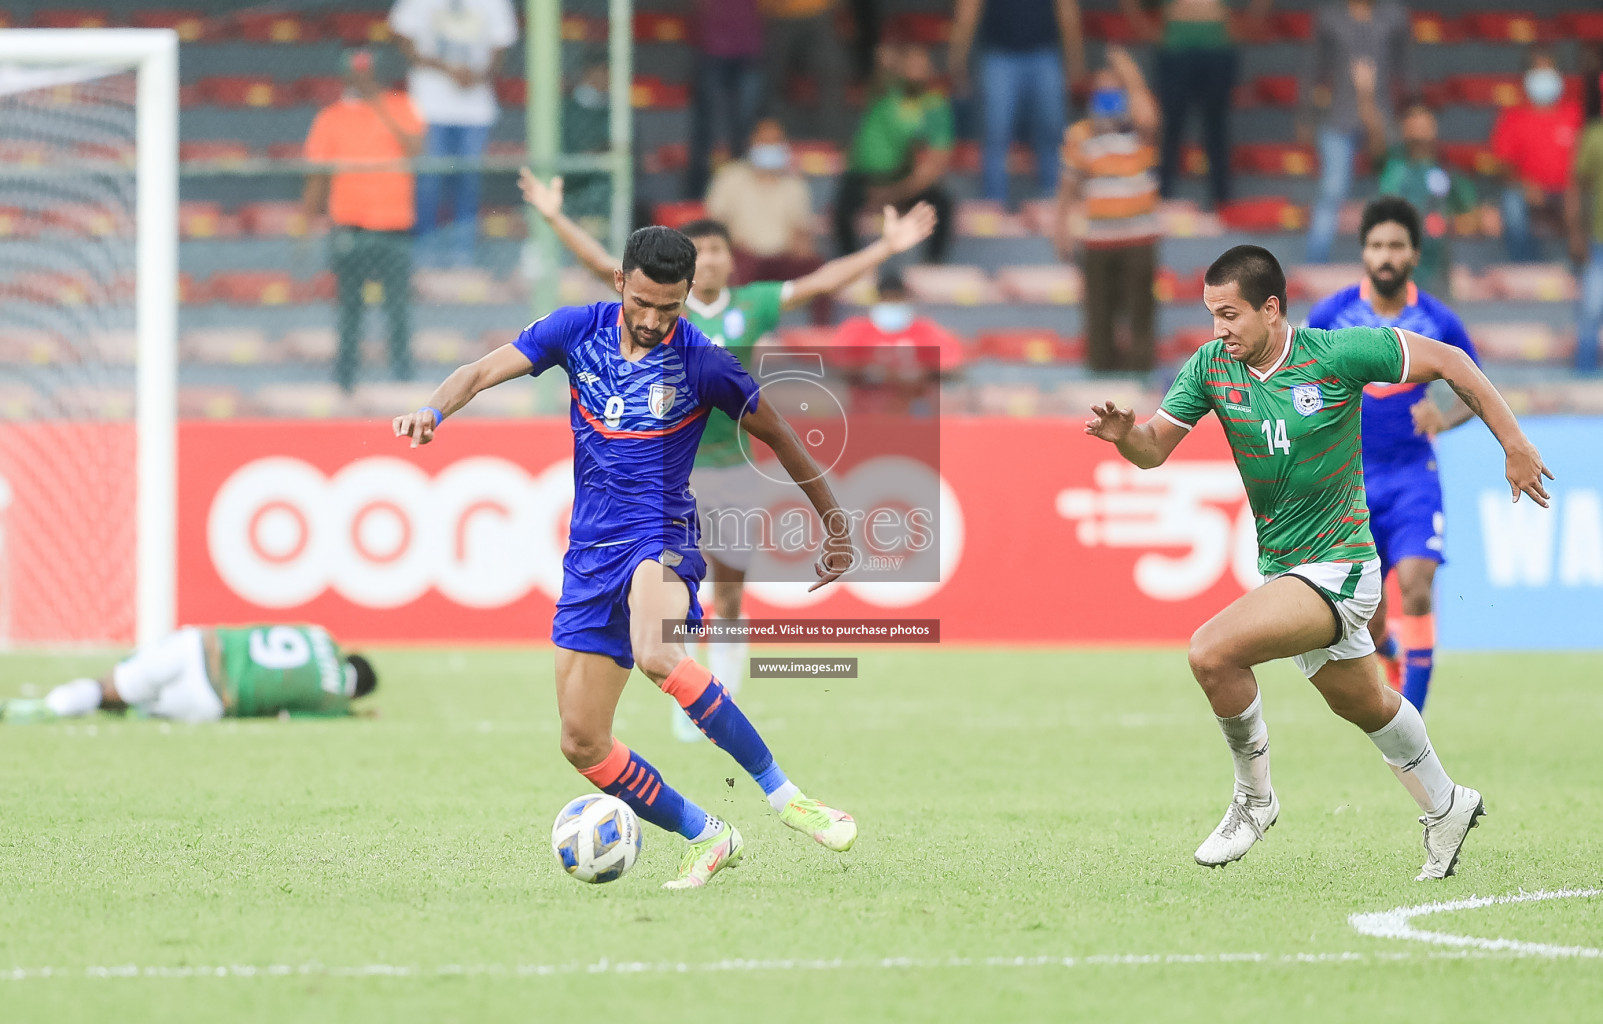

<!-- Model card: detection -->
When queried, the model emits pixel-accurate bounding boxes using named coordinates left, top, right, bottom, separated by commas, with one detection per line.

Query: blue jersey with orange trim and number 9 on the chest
left=513, top=303, right=757, bottom=548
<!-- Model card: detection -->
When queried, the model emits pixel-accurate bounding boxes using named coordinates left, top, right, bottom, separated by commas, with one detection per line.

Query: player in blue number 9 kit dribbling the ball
left=393, top=228, right=858, bottom=888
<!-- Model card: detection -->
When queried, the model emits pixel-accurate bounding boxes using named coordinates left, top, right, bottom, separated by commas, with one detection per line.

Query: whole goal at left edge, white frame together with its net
left=0, top=30, right=178, bottom=646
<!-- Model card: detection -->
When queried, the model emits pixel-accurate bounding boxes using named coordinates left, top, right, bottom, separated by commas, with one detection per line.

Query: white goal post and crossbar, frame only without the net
left=0, top=29, right=178, bottom=644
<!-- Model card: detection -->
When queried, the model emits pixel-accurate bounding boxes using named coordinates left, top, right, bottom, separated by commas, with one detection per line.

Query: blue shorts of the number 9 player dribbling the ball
left=551, top=537, right=707, bottom=668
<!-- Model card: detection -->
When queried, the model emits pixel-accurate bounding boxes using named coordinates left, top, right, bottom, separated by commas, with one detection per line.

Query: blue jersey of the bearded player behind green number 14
left=1308, top=279, right=1481, bottom=466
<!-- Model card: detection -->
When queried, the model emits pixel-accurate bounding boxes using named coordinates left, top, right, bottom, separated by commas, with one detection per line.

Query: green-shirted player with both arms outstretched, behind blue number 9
left=518, top=168, right=935, bottom=740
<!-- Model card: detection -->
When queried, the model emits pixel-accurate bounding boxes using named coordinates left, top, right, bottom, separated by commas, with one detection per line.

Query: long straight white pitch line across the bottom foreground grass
left=0, top=950, right=1570, bottom=981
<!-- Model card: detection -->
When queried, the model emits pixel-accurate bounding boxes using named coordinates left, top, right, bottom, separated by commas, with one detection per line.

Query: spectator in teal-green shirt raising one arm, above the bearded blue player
left=1355, top=86, right=1478, bottom=295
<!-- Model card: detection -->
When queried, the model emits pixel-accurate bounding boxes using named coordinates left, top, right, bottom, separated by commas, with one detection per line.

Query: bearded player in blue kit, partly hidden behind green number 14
left=1308, top=196, right=1480, bottom=710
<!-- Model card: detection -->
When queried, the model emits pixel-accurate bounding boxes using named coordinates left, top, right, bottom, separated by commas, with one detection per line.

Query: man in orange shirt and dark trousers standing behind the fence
left=301, top=50, right=423, bottom=391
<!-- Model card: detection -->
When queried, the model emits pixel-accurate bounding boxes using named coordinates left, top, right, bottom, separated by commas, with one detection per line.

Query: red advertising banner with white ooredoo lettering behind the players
left=178, top=418, right=1257, bottom=643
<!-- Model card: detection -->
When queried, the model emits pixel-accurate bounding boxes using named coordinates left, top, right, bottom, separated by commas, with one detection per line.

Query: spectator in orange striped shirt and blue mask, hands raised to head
left=1053, top=46, right=1161, bottom=373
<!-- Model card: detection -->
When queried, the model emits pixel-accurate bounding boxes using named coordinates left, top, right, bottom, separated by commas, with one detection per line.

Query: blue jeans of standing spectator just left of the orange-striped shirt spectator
left=979, top=46, right=1068, bottom=202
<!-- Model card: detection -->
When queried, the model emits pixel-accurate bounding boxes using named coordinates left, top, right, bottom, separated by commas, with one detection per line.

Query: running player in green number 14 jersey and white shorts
left=1085, top=245, right=1552, bottom=880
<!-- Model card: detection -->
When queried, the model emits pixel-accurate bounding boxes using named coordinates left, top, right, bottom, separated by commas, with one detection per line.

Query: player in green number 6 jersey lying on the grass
left=0, top=625, right=378, bottom=723
